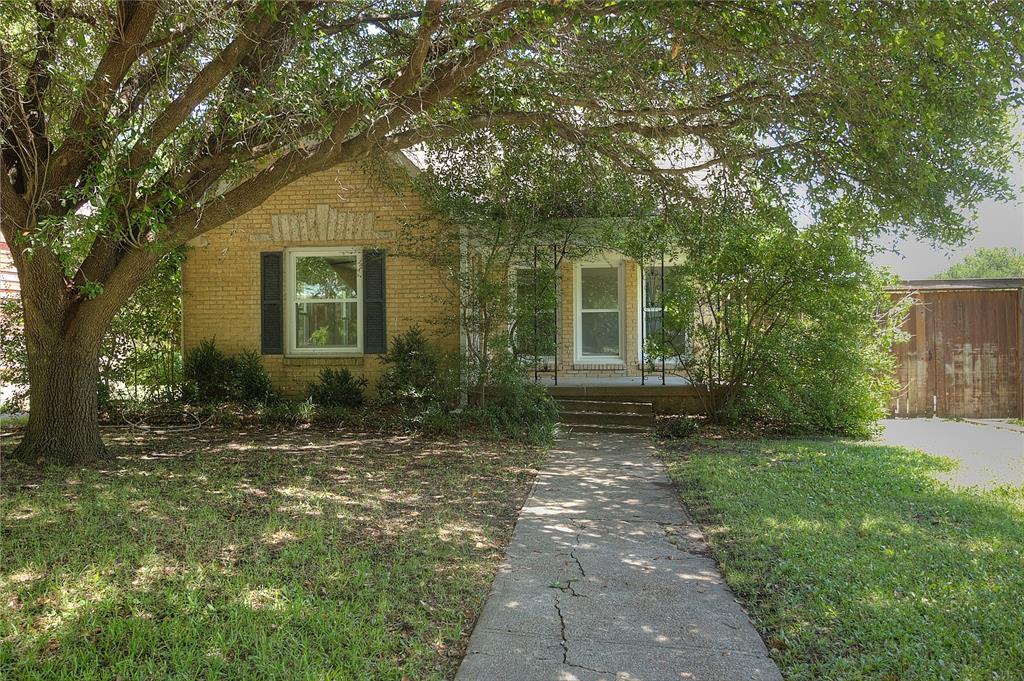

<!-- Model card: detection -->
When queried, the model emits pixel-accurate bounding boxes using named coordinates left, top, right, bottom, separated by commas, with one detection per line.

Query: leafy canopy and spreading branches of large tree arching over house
left=0, top=0, right=1024, bottom=462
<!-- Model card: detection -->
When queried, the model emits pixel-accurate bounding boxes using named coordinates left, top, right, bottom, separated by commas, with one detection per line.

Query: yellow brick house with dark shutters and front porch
left=182, top=156, right=691, bottom=408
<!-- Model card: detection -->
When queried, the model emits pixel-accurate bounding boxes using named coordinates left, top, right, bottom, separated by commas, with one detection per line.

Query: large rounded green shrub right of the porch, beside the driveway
left=648, top=201, right=902, bottom=436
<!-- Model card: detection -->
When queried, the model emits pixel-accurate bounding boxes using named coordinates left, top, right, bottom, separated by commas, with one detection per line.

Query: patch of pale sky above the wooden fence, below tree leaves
left=874, top=118, right=1024, bottom=279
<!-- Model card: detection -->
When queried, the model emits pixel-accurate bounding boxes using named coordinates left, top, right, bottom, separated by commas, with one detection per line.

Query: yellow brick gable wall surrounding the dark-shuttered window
left=182, top=159, right=459, bottom=395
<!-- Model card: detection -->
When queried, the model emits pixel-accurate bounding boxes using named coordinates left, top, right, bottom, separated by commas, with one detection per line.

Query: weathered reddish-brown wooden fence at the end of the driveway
left=891, top=280, right=1024, bottom=418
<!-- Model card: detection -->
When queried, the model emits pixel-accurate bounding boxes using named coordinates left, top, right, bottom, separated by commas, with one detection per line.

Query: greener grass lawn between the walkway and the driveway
left=663, top=440, right=1024, bottom=681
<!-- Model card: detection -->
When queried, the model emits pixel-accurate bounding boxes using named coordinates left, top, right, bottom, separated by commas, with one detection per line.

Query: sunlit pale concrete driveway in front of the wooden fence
left=882, top=419, right=1024, bottom=487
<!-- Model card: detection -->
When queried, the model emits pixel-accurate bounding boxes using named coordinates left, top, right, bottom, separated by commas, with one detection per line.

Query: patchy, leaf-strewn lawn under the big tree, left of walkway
left=0, top=430, right=542, bottom=680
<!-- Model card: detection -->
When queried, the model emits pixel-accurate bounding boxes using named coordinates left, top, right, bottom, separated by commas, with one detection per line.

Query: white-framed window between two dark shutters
left=286, top=248, right=362, bottom=354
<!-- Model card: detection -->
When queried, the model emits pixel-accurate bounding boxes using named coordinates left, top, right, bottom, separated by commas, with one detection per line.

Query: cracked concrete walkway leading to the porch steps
left=456, top=434, right=781, bottom=681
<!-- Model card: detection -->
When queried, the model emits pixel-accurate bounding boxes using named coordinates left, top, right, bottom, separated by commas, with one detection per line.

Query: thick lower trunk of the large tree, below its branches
left=13, top=331, right=106, bottom=465
